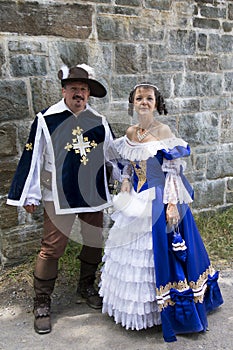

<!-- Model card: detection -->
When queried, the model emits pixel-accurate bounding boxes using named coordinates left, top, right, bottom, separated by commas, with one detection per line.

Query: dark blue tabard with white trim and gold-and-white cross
left=8, top=105, right=113, bottom=214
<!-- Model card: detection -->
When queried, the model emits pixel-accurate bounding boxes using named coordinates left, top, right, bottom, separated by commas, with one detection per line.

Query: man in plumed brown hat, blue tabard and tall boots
left=7, top=64, right=116, bottom=334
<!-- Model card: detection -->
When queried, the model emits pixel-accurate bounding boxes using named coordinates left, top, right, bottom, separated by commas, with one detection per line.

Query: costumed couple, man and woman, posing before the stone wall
left=7, top=64, right=223, bottom=342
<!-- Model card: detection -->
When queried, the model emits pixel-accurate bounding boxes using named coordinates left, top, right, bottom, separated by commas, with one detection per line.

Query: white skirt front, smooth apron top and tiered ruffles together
left=99, top=187, right=161, bottom=330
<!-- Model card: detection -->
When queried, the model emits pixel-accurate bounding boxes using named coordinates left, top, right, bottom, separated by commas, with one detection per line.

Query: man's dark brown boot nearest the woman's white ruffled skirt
left=76, top=261, right=102, bottom=309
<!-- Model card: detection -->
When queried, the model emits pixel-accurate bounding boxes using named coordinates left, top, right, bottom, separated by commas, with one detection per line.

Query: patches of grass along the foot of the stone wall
left=0, top=207, right=233, bottom=285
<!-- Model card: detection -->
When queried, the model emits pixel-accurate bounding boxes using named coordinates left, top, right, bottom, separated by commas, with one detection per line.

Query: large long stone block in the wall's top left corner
left=0, top=1, right=93, bottom=39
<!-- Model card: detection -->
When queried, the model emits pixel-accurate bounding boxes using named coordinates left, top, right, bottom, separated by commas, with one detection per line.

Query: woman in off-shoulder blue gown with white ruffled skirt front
left=100, top=82, right=223, bottom=342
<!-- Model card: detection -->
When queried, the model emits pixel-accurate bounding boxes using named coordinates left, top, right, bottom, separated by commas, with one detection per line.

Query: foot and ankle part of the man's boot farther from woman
left=33, top=295, right=52, bottom=334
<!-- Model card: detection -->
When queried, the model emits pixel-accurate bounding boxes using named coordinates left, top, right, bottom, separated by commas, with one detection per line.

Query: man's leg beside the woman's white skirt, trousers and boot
left=77, top=212, right=103, bottom=309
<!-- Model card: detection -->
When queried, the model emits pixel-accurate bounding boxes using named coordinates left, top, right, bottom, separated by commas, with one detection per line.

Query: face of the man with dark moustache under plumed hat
left=62, top=81, right=90, bottom=114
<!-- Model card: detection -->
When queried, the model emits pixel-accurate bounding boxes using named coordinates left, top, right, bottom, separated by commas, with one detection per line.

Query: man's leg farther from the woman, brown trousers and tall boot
left=34, top=202, right=75, bottom=334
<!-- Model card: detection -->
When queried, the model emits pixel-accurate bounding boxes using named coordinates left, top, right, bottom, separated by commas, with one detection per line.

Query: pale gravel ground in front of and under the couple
left=0, top=268, right=233, bottom=350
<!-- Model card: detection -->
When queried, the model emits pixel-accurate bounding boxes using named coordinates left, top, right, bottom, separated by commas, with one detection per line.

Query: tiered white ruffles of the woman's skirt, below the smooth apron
left=99, top=231, right=161, bottom=330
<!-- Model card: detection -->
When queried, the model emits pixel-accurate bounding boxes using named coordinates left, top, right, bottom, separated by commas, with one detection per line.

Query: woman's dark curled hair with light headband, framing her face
left=128, top=81, right=168, bottom=116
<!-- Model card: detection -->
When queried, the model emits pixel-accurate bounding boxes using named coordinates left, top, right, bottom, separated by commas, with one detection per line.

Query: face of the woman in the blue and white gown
left=134, top=87, right=156, bottom=115
